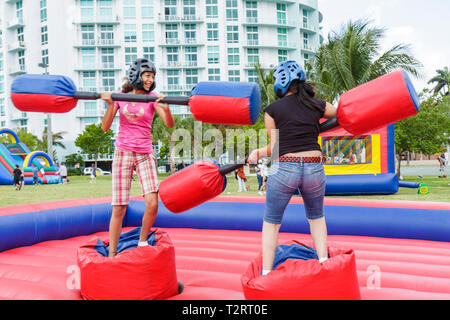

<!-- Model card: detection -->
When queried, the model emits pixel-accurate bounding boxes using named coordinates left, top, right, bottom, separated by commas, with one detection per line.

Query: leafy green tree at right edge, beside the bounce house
left=395, top=92, right=450, bottom=176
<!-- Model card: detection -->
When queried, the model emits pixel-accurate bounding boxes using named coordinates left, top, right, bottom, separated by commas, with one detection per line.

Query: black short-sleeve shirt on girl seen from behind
left=264, top=94, right=326, bottom=156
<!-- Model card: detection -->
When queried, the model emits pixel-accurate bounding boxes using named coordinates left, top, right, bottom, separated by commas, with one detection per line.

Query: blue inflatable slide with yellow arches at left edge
left=0, top=128, right=60, bottom=185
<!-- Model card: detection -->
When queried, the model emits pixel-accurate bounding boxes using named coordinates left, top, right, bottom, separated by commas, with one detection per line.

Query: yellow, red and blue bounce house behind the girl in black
left=319, top=125, right=399, bottom=195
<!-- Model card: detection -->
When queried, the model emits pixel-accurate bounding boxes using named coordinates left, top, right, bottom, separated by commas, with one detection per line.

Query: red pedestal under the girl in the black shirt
left=241, top=241, right=361, bottom=300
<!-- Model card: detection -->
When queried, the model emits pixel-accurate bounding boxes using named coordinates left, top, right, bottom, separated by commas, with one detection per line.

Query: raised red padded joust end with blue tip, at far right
left=337, top=71, right=419, bottom=135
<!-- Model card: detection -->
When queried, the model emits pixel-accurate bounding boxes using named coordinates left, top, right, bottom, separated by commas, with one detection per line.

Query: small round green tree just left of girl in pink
left=75, top=123, right=114, bottom=167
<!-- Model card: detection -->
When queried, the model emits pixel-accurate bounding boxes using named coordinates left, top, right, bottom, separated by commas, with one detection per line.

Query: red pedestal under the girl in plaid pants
left=77, top=229, right=178, bottom=300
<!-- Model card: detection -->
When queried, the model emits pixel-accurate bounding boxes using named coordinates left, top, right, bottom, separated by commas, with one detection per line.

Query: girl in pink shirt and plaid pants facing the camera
left=102, top=59, right=174, bottom=257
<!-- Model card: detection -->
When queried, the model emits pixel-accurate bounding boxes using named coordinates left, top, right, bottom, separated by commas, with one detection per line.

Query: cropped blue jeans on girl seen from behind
left=264, top=162, right=326, bottom=224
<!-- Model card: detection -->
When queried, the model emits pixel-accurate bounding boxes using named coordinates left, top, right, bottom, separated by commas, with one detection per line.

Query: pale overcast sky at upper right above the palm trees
left=318, top=0, right=450, bottom=92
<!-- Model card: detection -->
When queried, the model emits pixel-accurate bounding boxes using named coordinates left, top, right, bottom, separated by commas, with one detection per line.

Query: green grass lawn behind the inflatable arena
left=0, top=174, right=450, bottom=207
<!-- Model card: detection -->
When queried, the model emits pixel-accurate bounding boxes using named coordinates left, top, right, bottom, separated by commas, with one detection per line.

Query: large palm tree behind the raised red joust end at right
left=306, top=20, right=421, bottom=102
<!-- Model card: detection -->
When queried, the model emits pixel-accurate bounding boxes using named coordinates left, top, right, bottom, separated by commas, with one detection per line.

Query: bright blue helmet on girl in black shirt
left=273, top=60, right=306, bottom=98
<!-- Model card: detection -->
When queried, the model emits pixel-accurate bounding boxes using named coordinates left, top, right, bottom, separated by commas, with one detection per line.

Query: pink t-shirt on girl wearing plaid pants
left=114, top=92, right=156, bottom=153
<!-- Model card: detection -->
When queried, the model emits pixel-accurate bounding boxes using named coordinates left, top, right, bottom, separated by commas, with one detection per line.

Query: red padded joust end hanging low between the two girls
left=159, top=160, right=226, bottom=213
